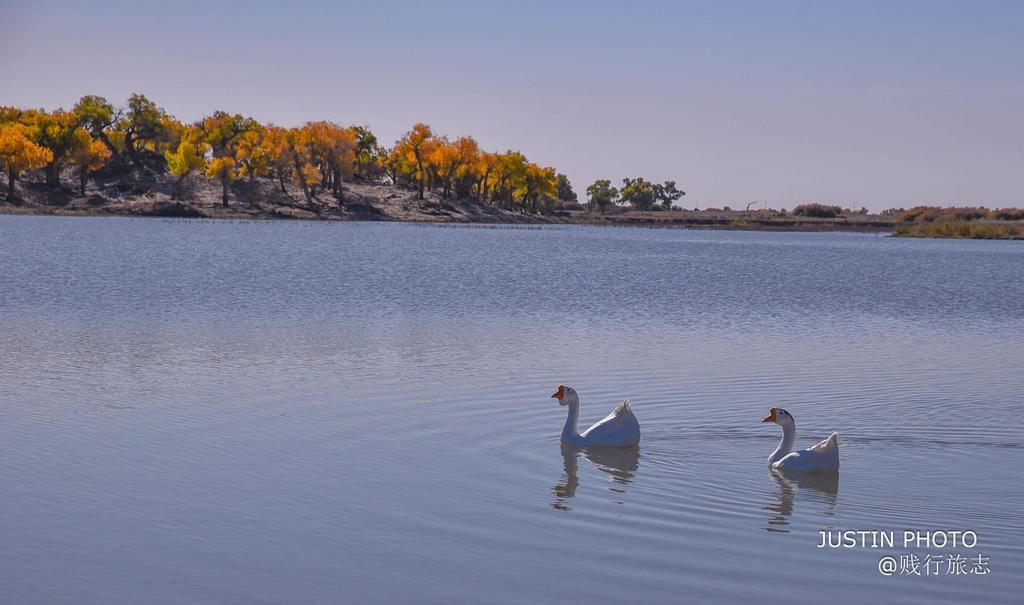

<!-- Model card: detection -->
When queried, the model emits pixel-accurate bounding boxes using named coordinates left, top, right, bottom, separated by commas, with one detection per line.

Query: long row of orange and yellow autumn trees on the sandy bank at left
left=0, top=94, right=577, bottom=212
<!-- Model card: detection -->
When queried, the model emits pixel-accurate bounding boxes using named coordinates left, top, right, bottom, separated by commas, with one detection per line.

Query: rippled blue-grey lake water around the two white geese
left=0, top=216, right=1024, bottom=605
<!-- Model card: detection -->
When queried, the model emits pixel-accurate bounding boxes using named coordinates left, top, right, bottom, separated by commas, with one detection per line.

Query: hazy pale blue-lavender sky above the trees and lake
left=0, top=0, right=1024, bottom=210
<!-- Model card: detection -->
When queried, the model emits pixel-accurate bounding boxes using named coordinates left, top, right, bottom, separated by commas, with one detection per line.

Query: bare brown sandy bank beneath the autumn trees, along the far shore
left=0, top=172, right=1013, bottom=236
